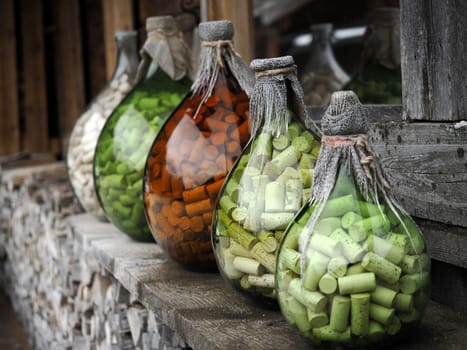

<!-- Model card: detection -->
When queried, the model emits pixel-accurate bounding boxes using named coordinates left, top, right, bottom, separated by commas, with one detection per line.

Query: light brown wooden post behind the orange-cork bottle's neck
left=207, top=0, right=255, bottom=63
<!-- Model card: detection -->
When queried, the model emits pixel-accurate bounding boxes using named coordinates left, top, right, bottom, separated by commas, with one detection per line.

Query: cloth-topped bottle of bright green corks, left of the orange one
left=93, top=16, right=191, bottom=241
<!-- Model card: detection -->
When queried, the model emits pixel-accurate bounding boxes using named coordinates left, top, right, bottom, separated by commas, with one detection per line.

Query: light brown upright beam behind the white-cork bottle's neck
left=102, top=0, right=135, bottom=79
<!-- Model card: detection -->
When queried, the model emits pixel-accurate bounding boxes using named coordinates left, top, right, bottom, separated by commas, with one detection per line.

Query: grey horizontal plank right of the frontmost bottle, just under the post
left=369, top=122, right=467, bottom=227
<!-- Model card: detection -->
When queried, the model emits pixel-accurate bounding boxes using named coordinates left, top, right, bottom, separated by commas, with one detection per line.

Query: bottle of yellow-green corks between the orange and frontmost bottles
left=212, top=56, right=320, bottom=306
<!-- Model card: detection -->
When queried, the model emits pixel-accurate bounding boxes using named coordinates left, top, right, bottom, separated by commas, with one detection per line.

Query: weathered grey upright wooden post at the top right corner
left=401, top=0, right=467, bottom=121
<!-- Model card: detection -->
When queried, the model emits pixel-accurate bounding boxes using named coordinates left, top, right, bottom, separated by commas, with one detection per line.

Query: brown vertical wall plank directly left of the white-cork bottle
left=54, top=1, right=86, bottom=154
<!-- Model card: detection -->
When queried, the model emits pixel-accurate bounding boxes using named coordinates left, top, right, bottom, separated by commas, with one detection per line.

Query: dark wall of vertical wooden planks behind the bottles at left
left=0, top=0, right=199, bottom=158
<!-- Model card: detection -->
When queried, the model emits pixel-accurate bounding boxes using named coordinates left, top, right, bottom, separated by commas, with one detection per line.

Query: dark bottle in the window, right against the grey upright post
left=345, top=7, right=402, bottom=104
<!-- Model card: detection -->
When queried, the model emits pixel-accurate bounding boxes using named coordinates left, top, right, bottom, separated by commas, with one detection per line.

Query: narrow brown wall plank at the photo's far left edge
left=0, top=0, right=20, bottom=155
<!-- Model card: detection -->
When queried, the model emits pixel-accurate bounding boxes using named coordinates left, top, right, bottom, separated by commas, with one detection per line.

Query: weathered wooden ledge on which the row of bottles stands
left=66, top=215, right=467, bottom=350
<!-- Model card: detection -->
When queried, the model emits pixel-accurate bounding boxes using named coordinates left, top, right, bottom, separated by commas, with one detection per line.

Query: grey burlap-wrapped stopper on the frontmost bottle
left=321, top=90, right=369, bottom=136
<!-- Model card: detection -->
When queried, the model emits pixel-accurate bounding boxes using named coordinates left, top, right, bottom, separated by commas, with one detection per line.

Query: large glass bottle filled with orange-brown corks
left=144, top=21, right=254, bottom=271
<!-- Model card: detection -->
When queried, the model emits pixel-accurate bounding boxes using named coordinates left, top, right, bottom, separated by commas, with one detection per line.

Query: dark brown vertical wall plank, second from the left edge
left=20, top=0, right=49, bottom=152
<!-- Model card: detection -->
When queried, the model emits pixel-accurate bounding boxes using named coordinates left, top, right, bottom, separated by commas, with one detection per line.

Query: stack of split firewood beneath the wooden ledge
left=0, top=163, right=187, bottom=350
